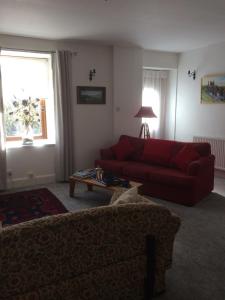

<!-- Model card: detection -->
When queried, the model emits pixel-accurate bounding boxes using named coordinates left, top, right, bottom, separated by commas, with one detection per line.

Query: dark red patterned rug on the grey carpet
left=0, top=188, right=67, bottom=227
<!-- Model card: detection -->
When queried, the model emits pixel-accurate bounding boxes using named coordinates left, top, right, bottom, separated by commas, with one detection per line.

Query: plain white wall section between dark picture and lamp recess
left=113, top=47, right=143, bottom=141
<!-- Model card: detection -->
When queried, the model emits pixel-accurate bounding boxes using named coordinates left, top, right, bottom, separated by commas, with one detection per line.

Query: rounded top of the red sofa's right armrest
left=187, top=155, right=215, bottom=176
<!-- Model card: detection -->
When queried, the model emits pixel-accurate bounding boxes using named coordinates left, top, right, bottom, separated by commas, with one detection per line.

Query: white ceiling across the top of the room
left=0, top=0, right=225, bottom=52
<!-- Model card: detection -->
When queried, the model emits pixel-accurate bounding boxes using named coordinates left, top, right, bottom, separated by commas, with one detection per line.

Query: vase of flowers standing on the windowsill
left=9, top=96, right=40, bottom=145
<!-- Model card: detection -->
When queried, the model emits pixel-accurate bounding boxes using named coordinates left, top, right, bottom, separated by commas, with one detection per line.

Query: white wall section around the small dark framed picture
left=73, top=45, right=113, bottom=169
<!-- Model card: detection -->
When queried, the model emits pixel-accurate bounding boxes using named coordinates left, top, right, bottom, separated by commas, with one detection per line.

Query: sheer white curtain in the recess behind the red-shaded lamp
left=142, top=70, right=168, bottom=138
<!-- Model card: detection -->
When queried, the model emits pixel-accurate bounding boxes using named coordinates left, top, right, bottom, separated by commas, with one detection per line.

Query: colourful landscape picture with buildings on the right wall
left=201, top=74, right=225, bottom=104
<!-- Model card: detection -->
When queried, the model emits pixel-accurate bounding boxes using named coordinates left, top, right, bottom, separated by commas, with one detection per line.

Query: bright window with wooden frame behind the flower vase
left=0, top=50, right=54, bottom=143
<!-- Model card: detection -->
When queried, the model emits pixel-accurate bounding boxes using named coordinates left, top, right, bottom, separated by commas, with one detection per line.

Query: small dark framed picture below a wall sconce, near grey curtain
left=77, top=86, right=106, bottom=104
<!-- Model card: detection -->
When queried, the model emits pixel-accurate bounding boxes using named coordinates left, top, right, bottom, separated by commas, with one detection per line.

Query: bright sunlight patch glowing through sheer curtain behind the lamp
left=142, top=88, right=160, bottom=132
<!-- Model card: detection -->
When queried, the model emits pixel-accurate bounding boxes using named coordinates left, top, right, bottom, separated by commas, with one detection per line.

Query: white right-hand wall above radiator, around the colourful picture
left=176, top=43, right=225, bottom=141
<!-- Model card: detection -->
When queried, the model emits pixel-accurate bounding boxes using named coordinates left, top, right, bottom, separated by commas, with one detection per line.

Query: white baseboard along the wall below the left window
left=7, top=174, right=55, bottom=189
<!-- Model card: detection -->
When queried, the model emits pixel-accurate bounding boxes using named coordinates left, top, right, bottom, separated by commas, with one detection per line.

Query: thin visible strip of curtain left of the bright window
left=0, top=49, right=7, bottom=190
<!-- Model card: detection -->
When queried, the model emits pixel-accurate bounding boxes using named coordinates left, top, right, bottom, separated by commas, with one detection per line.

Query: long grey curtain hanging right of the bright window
left=53, top=50, right=74, bottom=181
